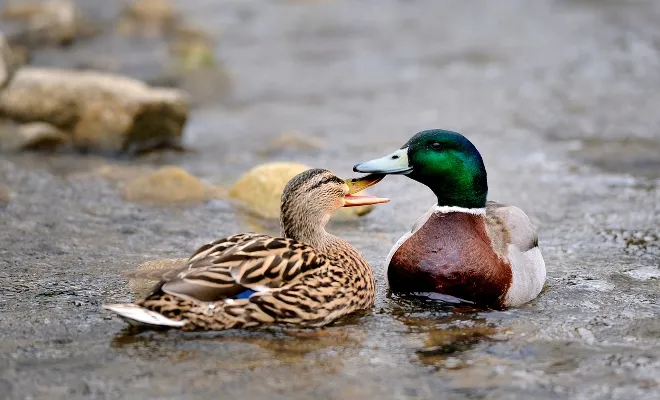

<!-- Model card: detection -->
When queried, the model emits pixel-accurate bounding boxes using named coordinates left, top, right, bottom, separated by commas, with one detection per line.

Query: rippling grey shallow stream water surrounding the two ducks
left=0, top=0, right=660, bottom=399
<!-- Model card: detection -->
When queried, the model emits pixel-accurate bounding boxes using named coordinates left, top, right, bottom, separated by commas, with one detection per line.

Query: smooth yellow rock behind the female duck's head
left=229, top=162, right=373, bottom=221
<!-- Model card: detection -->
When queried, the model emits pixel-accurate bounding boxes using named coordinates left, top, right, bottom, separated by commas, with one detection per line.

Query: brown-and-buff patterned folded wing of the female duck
left=162, top=235, right=325, bottom=301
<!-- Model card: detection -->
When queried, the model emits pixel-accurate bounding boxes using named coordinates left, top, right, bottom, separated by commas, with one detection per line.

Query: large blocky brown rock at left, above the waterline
left=0, top=67, right=189, bottom=153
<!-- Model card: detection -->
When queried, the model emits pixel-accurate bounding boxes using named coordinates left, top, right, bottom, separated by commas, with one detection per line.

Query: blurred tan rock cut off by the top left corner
left=0, top=0, right=79, bottom=47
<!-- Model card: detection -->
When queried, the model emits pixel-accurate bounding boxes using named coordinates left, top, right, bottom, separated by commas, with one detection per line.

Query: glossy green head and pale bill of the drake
left=353, top=129, right=488, bottom=208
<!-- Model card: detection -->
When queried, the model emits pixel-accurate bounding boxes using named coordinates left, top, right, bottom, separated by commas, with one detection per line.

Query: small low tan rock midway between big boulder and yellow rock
left=124, top=167, right=220, bottom=205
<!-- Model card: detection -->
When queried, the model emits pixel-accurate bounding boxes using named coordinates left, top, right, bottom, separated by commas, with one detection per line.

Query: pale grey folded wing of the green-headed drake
left=486, top=201, right=538, bottom=254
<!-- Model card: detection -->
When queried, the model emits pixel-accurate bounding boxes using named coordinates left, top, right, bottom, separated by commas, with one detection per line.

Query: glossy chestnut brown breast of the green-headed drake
left=387, top=212, right=512, bottom=307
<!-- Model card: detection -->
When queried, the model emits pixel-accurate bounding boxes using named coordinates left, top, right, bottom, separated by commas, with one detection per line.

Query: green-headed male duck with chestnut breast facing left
left=354, top=129, right=545, bottom=308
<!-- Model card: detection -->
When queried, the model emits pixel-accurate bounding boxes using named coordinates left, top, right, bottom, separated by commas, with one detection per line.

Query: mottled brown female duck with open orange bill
left=104, top=169, right=389, bottom=330
